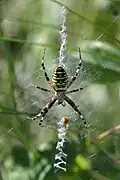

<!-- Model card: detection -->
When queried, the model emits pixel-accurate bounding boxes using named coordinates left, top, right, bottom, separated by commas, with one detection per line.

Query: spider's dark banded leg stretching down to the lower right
left=65, top=96, right=87, bottom=129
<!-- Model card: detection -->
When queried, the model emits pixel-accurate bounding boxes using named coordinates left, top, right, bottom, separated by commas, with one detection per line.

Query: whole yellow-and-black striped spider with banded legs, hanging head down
left=28, top=49, right=87, bottom=127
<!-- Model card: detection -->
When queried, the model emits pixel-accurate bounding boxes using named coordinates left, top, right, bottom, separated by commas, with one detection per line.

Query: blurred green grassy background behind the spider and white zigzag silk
left=0, top=0, right=120, bottom=180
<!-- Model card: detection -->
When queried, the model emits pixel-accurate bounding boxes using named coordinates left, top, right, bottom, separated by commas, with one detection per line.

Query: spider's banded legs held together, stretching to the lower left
left=28, top=96, right=57, bottom=126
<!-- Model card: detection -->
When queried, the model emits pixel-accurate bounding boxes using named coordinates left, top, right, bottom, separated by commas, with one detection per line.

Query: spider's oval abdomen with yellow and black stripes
left=52, top=66, right=68, bottom=88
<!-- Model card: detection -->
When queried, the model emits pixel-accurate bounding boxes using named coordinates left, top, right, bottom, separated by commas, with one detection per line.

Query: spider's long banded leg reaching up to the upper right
left=67, top=48, right=82, bottom=88
